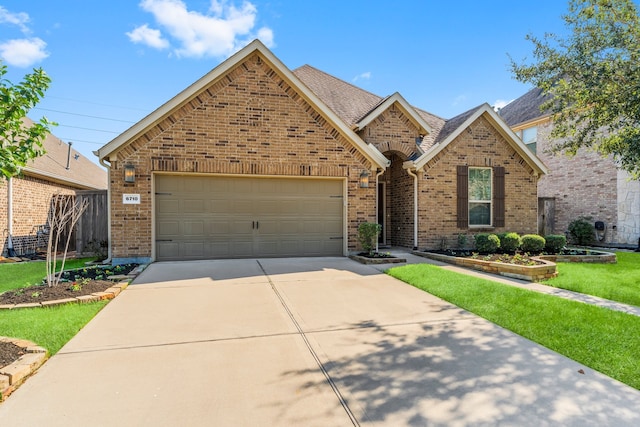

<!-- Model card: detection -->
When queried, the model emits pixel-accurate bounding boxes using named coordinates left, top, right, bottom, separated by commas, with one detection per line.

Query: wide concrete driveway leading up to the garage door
left=0, top=258, right=640, bottom=427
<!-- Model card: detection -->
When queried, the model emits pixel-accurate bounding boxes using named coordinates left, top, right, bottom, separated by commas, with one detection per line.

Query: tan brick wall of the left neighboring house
left=0, top=176, right=75, bottom=255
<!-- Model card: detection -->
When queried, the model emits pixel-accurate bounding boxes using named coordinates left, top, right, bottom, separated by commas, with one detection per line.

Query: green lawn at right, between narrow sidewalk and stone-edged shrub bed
left=544, top=252, right=640, bottom=306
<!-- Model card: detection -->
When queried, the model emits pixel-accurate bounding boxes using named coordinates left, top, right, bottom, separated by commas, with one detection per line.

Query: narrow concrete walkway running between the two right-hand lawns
left=373, top=248, right=640, bottom=316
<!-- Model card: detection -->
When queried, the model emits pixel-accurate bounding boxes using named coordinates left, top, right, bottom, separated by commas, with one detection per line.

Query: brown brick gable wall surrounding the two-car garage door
left=109, top=53, right=376, bottom=258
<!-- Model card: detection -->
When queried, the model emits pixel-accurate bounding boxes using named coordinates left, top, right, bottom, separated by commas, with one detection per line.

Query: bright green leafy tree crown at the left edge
left=0, top=63, right=55, bottom=179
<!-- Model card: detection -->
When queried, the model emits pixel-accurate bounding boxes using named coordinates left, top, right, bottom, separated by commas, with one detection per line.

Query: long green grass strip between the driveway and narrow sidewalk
left=387, top=266, right=640, bottom=390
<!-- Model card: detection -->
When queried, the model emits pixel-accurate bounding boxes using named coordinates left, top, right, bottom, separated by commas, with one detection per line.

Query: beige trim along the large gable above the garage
left=98, top=39, right=389, bottom=169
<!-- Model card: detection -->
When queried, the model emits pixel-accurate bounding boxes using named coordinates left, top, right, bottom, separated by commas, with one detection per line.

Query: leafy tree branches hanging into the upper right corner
left=511, top=0, right=640, bottom=179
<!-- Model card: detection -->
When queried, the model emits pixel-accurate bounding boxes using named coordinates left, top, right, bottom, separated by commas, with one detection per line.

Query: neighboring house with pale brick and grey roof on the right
left=500, top=89, right=640, bottom=246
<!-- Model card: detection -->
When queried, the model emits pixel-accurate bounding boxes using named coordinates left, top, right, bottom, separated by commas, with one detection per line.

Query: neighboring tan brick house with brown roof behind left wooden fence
left=0, top=118, right=107, bottom=256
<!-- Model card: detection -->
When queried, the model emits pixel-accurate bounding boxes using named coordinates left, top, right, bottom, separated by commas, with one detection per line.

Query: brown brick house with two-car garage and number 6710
left=96, top=40, right=546, bottom=263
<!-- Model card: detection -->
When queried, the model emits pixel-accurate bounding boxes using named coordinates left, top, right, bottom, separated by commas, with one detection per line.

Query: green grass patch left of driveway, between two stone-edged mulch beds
left=0, top=301, right=107, bottom=355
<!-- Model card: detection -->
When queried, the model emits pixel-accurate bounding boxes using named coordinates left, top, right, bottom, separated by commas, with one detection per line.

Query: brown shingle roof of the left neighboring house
left=22, top=117, right=107, bottom=190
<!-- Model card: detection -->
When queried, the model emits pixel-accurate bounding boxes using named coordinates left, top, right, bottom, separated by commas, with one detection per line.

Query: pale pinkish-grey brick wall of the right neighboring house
left=537, top=122, right=618, bottom=243
